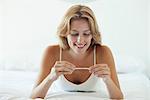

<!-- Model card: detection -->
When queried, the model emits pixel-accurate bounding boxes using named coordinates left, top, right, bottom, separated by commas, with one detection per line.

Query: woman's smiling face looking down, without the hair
left=67, top=19, right=92, bottom=54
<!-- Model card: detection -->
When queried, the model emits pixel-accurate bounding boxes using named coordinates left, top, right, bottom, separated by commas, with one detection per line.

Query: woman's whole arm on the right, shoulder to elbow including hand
left=91, top=46, right=123, bottom=99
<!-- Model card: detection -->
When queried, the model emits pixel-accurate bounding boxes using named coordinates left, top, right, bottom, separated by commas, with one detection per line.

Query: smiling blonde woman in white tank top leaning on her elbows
left=31, top=5, right=123, bottom=99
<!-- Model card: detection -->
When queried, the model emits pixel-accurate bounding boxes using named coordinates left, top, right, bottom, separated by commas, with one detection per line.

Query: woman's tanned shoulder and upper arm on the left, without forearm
left=35, top=45, right=59, bottom=87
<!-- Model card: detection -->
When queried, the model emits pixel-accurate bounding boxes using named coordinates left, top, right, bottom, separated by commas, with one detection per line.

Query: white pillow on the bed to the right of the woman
left=115, top=55, right=146, bottom=73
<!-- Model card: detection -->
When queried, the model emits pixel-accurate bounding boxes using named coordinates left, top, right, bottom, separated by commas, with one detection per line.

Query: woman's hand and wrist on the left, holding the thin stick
left=49, top=61, right=76, bottom=81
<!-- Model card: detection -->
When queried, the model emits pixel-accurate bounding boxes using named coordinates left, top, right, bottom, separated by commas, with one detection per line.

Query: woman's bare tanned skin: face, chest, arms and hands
left=31, top=19, right=123, bottom=99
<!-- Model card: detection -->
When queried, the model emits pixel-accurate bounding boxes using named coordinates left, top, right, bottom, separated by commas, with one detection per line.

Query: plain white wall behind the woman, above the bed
left=0, top=0, right=150, bottom=73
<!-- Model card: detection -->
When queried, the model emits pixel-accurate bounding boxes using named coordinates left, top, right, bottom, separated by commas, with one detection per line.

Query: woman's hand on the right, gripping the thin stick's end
left=89, top=64, right=111, bottom=78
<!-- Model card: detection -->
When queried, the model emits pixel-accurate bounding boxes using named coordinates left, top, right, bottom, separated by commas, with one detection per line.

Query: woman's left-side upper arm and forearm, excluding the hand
left=30, top=46, right=56, bottom=99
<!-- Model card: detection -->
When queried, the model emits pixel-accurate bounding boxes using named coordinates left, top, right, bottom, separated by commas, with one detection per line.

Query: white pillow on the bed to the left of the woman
left=0, top=57, right=39, bottom=71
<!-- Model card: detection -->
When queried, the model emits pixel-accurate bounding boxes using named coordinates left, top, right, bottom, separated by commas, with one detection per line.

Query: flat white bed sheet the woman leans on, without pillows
left=0, top=71, right=150, bottom=100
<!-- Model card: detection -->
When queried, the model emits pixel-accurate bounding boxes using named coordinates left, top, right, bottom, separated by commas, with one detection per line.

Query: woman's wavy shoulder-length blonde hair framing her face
left=57, top=5, right=101, bottom=49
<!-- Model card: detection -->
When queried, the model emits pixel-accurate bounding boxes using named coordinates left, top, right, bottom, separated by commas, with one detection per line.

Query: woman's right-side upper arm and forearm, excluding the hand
left=102, top=46, right=123, bottom=99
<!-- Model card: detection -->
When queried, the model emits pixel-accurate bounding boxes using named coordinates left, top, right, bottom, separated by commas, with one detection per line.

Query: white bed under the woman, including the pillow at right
left=0, top=56, right=150, bottom=100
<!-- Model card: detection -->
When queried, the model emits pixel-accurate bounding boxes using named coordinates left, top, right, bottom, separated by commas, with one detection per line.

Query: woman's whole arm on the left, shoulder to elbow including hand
left=31, top=46, right=75, bottom=99
